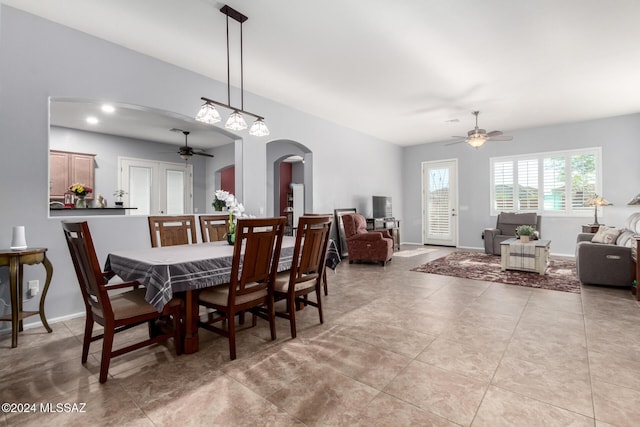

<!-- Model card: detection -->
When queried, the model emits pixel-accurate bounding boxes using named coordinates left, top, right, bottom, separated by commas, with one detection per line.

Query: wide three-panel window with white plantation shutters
left=490, top=148, right=602, bottom=216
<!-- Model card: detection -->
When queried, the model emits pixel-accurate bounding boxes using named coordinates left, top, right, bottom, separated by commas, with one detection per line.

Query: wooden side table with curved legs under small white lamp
left=0, top=248, right=53, bottom=348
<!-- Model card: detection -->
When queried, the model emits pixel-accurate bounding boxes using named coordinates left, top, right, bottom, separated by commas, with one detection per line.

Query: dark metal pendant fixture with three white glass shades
left=196, top=5, right=269, bottom=136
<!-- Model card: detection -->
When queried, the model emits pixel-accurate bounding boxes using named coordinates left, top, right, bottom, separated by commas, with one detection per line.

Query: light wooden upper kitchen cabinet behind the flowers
left=49, top=150, right=96, bottom=200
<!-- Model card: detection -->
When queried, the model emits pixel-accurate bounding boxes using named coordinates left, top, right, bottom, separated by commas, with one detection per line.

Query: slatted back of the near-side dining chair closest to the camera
left=229, top=217, right=286, bottom=305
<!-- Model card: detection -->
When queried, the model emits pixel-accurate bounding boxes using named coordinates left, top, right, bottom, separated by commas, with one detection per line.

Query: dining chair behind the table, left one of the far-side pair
left=149, top=215, right=197, bottom=248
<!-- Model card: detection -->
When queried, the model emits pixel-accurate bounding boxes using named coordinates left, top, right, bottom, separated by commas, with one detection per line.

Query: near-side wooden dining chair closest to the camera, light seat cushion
left=198, top=217, right=286, bottom=360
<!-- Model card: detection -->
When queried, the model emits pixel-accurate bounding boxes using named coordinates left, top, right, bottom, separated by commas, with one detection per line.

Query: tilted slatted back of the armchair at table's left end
left=62, top=221, right=111, bottom=313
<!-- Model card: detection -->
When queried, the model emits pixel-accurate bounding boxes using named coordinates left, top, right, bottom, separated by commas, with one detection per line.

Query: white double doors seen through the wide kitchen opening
left=118, top=158, right=193, bottom=215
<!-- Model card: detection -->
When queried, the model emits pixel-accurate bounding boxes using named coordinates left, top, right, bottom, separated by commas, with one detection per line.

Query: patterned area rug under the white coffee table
left=411, top=252, right=580, bottom=294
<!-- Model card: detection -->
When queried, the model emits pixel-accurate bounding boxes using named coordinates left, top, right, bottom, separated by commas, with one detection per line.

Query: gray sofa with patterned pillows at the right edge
left=576, top=213, right=640, bottom=286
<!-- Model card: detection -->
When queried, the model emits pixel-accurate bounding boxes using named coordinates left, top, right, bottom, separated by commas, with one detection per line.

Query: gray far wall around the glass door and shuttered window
left=404, top=114, right=640, bottom=255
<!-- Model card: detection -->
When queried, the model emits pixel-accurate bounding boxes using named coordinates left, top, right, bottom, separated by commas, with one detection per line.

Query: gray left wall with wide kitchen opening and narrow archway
left=0, top=5, right=402, bottom=329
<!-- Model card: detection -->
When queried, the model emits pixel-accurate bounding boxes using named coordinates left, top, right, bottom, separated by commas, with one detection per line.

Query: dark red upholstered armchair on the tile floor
left=342, top=214, right=393, bottom=266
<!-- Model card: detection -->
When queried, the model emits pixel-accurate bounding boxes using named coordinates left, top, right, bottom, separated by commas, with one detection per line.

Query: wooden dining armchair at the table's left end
left=62, top=221, right=182, bottom=383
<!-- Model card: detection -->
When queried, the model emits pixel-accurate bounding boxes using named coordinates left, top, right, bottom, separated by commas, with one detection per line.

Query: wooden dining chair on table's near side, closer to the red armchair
left=274, top=215, right=332, bottom=338
